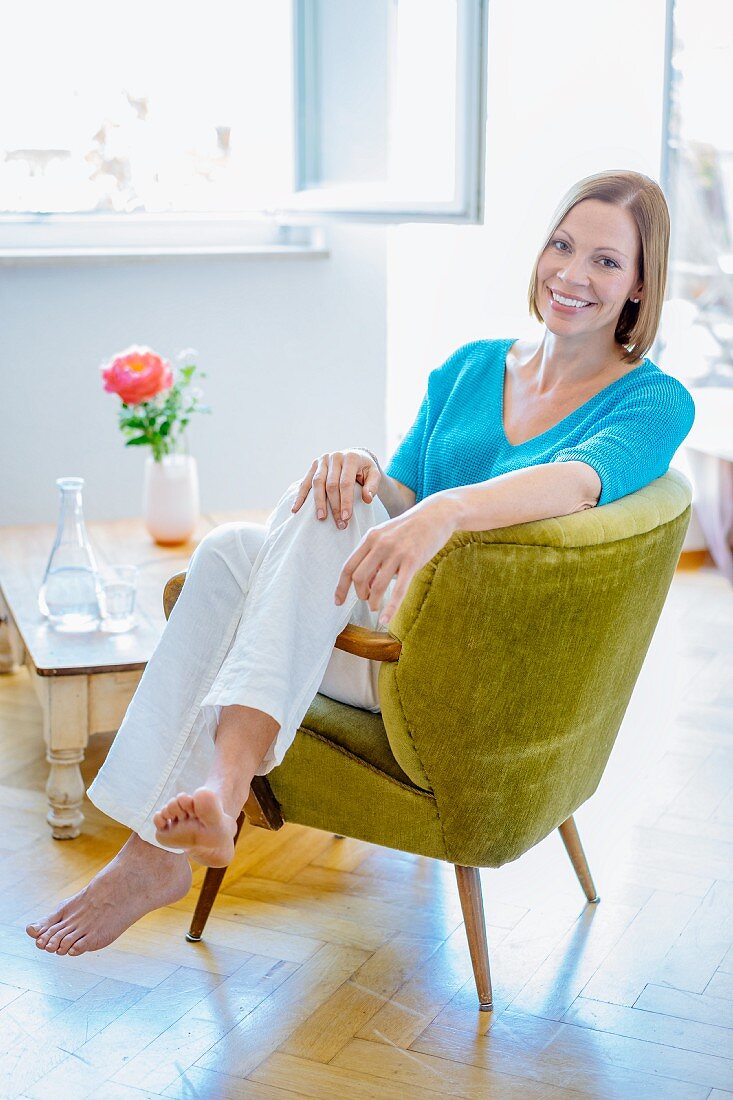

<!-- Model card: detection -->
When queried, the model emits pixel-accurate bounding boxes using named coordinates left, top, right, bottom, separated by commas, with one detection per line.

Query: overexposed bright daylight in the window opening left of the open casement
left=0, top=0, right=293, bottom=213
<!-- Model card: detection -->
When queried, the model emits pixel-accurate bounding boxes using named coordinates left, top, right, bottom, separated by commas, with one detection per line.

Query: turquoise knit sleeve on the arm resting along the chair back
left=551, top=375, right=694, bottom=506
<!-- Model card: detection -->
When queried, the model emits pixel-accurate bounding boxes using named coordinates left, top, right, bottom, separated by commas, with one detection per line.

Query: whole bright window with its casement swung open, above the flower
left=0, top=0, right=486, bottom=255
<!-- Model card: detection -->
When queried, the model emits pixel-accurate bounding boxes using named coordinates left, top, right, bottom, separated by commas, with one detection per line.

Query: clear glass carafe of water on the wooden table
left=39, top=477, right=100, bottom=633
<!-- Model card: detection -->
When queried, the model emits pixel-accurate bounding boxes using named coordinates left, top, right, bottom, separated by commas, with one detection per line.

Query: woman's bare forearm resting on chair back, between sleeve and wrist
left=433, top=462, right=601, bottom=531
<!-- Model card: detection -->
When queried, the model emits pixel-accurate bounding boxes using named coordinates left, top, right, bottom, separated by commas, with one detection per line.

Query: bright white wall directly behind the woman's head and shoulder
left=387, top=0, right=665, bottom=454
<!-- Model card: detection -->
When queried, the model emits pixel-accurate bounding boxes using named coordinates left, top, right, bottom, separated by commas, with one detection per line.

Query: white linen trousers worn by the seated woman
left=87, top=481, right=396, bottom=850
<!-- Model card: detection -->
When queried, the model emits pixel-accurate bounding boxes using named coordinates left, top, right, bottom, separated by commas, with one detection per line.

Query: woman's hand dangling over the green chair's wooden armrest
left=335, top=493, right=457, bottom=625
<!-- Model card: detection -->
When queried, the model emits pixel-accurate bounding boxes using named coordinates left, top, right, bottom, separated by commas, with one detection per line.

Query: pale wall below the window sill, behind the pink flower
left=0, top=226, right=386, bottom=525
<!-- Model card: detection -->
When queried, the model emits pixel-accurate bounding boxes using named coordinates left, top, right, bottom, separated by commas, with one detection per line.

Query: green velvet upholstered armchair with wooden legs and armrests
left=164, top=470, right=691, bottom=1010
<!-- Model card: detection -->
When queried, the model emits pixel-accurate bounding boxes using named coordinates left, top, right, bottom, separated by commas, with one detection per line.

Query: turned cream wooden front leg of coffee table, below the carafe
left=39, top=675, right=89, bottom=840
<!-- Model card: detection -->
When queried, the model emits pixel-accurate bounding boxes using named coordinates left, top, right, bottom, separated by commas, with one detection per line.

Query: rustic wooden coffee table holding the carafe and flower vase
left=0, top=509, right=271, bottom=840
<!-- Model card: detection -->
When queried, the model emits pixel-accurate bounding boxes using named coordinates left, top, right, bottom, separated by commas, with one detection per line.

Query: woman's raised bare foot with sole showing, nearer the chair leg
left=153, top=787, right=237, bottom=867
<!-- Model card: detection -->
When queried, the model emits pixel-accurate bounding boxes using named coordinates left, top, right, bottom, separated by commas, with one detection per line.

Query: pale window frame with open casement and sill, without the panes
left=0, top=0, right=489, bottom=263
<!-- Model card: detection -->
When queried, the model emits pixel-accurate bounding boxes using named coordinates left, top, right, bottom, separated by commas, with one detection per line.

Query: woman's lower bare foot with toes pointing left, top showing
left=25, top=834, right=192, bottom=955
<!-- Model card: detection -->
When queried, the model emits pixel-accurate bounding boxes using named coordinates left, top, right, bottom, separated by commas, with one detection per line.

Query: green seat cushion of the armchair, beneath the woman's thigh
left=300, top=693, right=428, bottom=790
